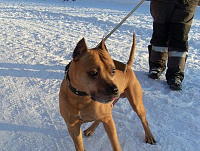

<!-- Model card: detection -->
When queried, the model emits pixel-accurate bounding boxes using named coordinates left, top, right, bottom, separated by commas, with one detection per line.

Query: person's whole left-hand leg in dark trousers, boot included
left=148, top=1, right=175, bottom=79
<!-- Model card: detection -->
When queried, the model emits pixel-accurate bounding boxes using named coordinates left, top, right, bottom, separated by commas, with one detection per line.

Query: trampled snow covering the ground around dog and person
left=0, top=0, right=200, bottom=151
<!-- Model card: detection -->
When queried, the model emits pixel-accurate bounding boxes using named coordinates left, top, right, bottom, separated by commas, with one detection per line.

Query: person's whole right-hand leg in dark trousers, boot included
left=166, top=3, right=196, bottom=90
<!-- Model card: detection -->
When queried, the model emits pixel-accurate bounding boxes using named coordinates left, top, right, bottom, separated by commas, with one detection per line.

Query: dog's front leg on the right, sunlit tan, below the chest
left=103, top=115, right=121, bottom=151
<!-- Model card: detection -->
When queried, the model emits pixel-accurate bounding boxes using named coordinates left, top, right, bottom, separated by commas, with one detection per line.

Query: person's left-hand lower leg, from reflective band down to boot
left=148, top=45, right=168, bottom=80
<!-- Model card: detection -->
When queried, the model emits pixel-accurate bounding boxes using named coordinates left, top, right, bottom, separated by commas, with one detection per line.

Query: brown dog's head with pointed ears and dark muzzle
left=72, top=38, right=119, bottom=103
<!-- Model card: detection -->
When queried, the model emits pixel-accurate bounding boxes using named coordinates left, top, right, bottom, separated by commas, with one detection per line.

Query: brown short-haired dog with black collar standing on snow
left=59, top=34, right=155, bottom=151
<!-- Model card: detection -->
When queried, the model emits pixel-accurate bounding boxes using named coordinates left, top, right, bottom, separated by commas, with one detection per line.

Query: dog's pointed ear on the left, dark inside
left=72, top=38, right=87, bottom=61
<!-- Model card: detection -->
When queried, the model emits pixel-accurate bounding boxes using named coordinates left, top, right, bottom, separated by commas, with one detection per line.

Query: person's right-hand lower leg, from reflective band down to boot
left=166, top=51, right=187, bottom=91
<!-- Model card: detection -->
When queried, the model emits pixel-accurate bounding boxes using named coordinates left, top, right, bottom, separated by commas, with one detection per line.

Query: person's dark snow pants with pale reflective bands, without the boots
left=149, top=0, right=198, bottom=80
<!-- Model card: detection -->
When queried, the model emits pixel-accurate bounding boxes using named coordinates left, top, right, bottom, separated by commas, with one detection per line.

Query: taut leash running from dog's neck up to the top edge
left=97, top=0, right=145, bottom=47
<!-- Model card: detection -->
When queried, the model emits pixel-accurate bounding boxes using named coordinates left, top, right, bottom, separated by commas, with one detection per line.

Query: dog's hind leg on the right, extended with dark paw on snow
left=125, top=80, right=156, bottom=144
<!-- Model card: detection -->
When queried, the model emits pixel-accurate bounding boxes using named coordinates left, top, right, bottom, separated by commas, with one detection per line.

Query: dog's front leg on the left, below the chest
left=67, top=123, right=84, bottom=151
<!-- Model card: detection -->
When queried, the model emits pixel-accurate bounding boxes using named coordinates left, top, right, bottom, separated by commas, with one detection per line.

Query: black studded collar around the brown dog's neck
left=65, top=62, right=88, bottom=96
